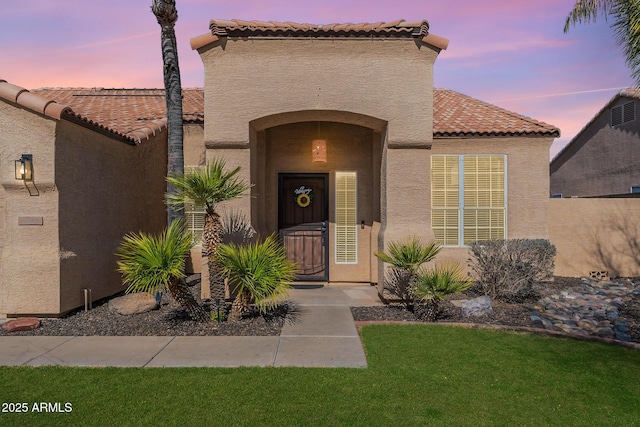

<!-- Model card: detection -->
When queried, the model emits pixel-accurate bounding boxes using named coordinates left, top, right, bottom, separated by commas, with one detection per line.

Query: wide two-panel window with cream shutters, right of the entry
left=431, top=155, right=507, bottom=246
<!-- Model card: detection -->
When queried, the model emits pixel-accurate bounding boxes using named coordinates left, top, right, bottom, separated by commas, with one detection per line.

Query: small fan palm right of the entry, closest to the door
left=375, top=236, right=441, bottom=301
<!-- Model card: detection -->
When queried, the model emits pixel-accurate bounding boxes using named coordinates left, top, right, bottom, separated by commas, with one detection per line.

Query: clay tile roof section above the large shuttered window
left=433, top=89, right=560, bottom=138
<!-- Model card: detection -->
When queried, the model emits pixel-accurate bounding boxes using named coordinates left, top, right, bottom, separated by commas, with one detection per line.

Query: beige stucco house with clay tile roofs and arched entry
left=0, top=20, right=559, bottom=315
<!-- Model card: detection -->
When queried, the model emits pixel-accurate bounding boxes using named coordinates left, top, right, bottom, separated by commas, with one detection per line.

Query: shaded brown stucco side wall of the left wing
left=56, top=120, right=167, bottom=312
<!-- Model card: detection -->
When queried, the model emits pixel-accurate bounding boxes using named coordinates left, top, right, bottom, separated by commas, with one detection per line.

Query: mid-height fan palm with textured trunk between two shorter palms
left=167, top=159, right=251, bottom=300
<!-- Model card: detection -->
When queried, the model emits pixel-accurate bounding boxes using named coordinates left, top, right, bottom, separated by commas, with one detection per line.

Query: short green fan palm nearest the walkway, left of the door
left=218, top=235, right=297, bottom=320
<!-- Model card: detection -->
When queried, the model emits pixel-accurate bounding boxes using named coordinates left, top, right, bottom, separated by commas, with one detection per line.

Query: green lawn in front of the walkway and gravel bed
left=0, top=325, right=640, bottom=427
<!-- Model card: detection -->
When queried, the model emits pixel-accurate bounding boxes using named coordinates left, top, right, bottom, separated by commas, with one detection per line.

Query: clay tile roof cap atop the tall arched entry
left=191, top=19, right=449, bottom=49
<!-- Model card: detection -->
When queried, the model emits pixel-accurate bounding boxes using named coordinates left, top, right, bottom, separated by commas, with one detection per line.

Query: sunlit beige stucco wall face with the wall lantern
left=0, top=101, right=60, bottom=314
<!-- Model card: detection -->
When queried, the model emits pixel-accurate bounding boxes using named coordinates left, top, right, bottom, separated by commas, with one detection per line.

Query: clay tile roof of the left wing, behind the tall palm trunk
left=32, top=88, right=204, bottom=143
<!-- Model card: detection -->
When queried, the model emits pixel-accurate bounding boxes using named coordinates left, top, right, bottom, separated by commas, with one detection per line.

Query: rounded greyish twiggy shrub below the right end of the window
left=469, top=239, right=556, bottom=302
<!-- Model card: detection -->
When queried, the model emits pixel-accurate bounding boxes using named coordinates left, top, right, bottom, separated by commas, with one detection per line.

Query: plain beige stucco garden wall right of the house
left=549, top=199, right=640, bottom=276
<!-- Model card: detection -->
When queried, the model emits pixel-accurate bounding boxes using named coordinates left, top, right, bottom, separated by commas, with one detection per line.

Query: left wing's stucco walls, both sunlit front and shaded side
left=0, top=98, right=167, bottom=315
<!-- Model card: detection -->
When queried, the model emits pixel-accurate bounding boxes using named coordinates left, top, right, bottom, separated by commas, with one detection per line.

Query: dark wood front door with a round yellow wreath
left=278, top=173, right=329, bottom=280
